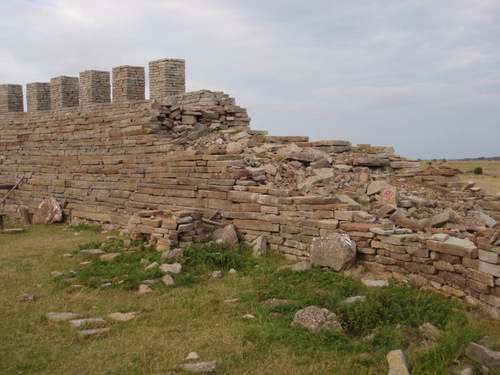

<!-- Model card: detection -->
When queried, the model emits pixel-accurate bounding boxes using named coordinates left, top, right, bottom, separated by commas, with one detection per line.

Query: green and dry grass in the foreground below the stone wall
left=0, top=224, right=500, bottom=375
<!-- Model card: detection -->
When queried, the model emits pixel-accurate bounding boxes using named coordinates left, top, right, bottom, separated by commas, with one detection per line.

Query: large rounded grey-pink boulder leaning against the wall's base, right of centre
left=311, top=233, right=356, bottom=272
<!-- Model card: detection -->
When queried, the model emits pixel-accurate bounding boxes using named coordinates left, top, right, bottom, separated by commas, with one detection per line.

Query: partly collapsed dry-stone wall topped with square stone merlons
left=0, top=60, right=500, bottom=306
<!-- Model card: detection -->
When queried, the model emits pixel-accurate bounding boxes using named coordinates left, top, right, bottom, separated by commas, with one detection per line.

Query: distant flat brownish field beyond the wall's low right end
left=421, top=160, right=500, bottom=194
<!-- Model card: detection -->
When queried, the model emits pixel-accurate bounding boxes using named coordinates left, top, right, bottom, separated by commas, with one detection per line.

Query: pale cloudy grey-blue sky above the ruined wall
left=0, top=0, right=500, bottom=159
